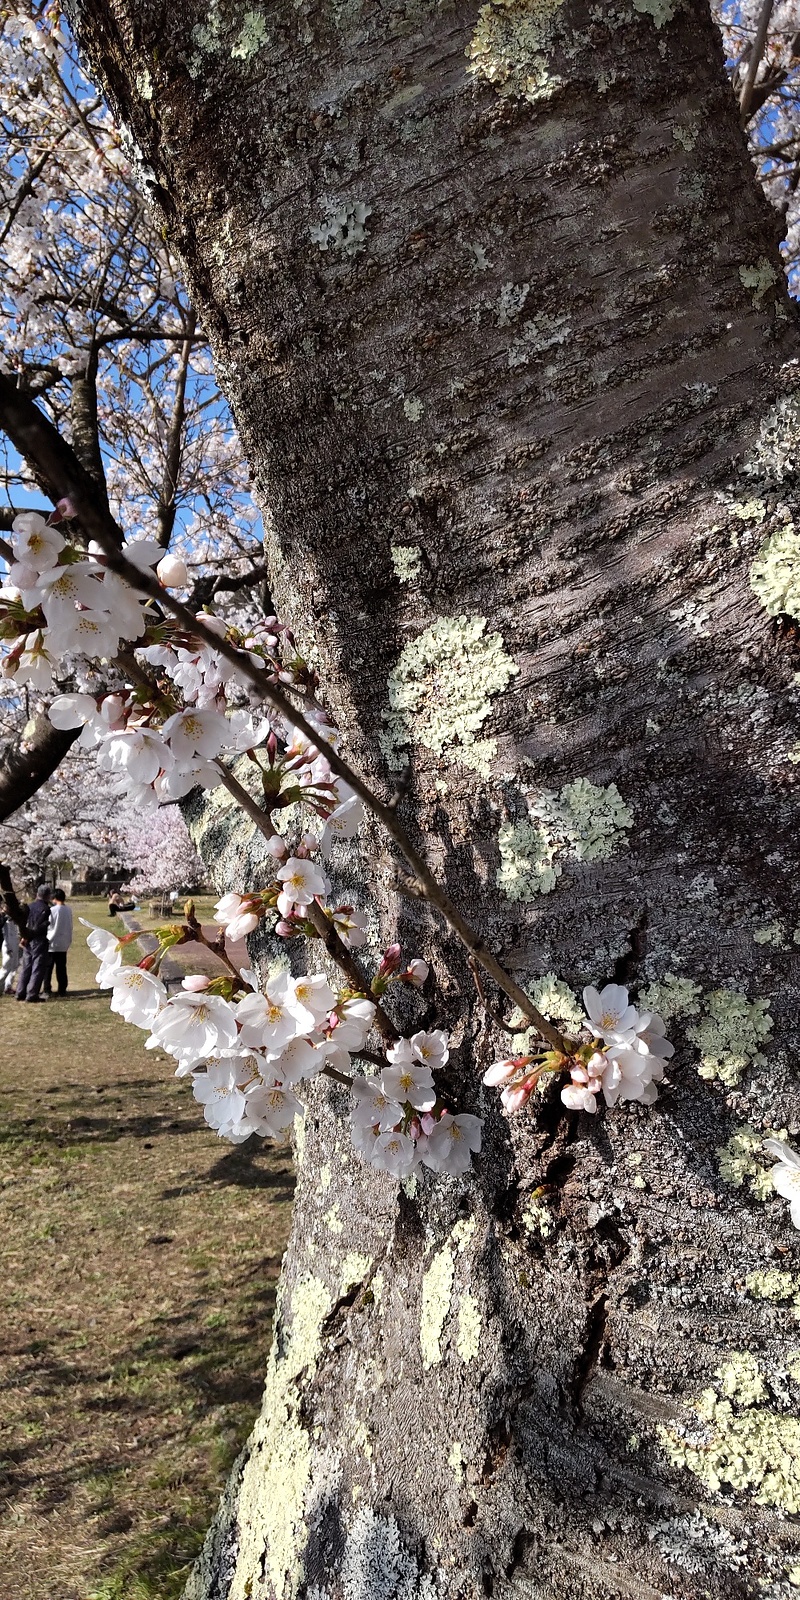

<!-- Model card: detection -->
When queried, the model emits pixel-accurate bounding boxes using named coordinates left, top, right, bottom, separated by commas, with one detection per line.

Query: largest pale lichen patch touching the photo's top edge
left=466, top=0, right=563, bottom=104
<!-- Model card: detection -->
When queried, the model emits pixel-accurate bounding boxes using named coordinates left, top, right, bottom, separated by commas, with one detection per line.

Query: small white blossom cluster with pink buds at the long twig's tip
left=483, top=984, right=674, bottom=1112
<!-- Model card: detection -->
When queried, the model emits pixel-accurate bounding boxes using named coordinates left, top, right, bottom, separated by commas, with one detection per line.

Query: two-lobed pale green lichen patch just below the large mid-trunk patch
left=496, top=778, right=634, bottom=901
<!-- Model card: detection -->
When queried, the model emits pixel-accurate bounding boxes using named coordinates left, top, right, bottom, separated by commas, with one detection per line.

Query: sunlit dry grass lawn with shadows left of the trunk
left=0, top=901, right=293, bottom=1600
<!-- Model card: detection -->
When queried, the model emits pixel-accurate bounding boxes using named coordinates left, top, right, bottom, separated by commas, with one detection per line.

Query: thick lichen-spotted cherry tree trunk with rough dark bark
left=69, top=0, right=800, bottom=1600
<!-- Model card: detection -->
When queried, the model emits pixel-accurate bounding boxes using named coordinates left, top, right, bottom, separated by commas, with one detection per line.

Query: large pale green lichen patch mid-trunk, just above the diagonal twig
left=381, top=616, right=520, bottom=776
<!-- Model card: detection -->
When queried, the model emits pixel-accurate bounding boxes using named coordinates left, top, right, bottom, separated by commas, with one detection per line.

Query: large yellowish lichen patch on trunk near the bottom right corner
left=659, top=1350, right=800, bottom=1515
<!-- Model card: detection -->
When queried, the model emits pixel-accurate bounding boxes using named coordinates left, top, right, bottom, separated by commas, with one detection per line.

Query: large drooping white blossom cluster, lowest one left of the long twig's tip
left=86, top=914, right=480, bottom=1178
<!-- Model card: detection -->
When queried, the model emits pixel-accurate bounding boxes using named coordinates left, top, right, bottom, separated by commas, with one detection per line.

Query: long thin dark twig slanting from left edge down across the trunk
left=0, top=373, right=565, bottom=1051
